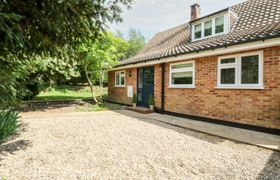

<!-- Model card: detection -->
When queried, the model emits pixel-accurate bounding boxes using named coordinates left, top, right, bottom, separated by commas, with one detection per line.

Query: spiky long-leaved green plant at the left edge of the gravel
left=0, top=110, right=19, bottom=142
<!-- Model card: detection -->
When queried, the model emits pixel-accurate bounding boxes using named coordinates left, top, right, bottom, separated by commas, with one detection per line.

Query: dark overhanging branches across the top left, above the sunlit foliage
left=0, top=0, right=132, bottom=52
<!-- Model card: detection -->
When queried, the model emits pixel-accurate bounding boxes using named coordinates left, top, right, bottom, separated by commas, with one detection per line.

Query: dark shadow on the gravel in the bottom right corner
left=256, top=151, right=280, bottom=180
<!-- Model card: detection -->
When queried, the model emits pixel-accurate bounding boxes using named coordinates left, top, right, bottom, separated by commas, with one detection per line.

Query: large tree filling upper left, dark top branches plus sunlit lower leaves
left=0, top=0, right=132, bottom=105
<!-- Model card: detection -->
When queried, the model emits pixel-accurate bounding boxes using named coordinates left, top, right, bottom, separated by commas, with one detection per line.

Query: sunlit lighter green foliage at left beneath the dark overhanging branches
left=0, top=48, right=79, bottom=105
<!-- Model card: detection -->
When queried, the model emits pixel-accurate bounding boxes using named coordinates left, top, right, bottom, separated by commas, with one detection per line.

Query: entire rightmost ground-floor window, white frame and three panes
left=217, top=52, right=263, bottom=89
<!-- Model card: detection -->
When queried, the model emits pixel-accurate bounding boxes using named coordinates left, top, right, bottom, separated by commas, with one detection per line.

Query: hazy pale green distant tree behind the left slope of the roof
left=126, top=29, right=146, bottom=58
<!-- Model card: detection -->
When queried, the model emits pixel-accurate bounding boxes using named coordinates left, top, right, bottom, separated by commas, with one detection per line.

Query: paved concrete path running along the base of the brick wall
left=120, top=111, right=280, bottom=151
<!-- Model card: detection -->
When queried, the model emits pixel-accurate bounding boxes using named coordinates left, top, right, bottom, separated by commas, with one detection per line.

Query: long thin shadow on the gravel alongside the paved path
left=114, top=111, right=226, bottom=144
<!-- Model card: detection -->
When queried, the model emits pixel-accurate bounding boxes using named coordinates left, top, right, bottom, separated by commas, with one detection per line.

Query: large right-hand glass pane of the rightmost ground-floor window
left=241, top=55, right=259, bottom=84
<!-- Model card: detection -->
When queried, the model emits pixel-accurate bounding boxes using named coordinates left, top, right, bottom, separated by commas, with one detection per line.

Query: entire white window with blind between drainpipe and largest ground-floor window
left=169, top=61, right=195, bottom=88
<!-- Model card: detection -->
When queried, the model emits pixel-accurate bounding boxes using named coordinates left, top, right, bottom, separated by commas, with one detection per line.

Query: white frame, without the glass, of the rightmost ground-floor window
left=216, top=51, right=264, bottom=89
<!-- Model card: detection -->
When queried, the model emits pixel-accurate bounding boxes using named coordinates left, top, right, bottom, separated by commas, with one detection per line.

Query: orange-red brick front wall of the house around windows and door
left=109, top=46, right=280, bottom=129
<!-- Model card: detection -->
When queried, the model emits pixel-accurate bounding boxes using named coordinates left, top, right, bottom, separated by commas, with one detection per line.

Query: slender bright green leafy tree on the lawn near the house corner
left=79, top=32, right=128, bottom=102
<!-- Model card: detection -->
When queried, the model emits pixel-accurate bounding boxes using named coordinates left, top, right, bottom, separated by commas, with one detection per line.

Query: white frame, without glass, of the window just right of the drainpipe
left=169, top=61, right=195, bottom=88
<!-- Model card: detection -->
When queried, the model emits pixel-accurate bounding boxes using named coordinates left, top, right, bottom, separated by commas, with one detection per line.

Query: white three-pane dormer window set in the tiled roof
left=192, top=14, right=229, bottom=41
